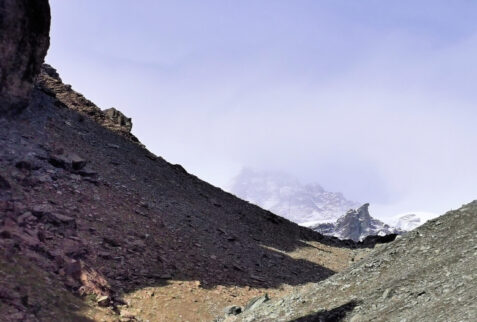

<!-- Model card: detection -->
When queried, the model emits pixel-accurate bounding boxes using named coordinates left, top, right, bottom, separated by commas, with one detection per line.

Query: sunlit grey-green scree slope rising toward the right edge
left=233, top=201, right=477, bottom=322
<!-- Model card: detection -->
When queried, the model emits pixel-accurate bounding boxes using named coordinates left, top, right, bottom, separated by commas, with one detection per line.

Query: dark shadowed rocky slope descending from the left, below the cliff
left=0, top=66, right=386, bottom=320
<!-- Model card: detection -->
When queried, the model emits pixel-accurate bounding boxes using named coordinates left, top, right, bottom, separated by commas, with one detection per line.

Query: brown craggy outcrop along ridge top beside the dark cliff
left=37, top=64, right=139, bottom=142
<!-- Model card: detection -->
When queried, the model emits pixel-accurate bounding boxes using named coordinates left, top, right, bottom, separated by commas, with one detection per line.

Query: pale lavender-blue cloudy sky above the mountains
left=46, top=0, right=477, bottom=218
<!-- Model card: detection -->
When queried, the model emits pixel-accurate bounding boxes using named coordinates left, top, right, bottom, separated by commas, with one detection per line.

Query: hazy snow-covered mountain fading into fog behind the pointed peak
left=229, top=169, right=359, bottom=226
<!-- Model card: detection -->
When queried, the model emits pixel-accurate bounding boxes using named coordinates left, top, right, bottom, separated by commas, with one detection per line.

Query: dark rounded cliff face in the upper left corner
left=0, top=0, right=50, bottom=116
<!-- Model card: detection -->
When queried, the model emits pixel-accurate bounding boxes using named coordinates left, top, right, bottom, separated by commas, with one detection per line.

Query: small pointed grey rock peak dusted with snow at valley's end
left=310, top=203, right=404, bottom=241
